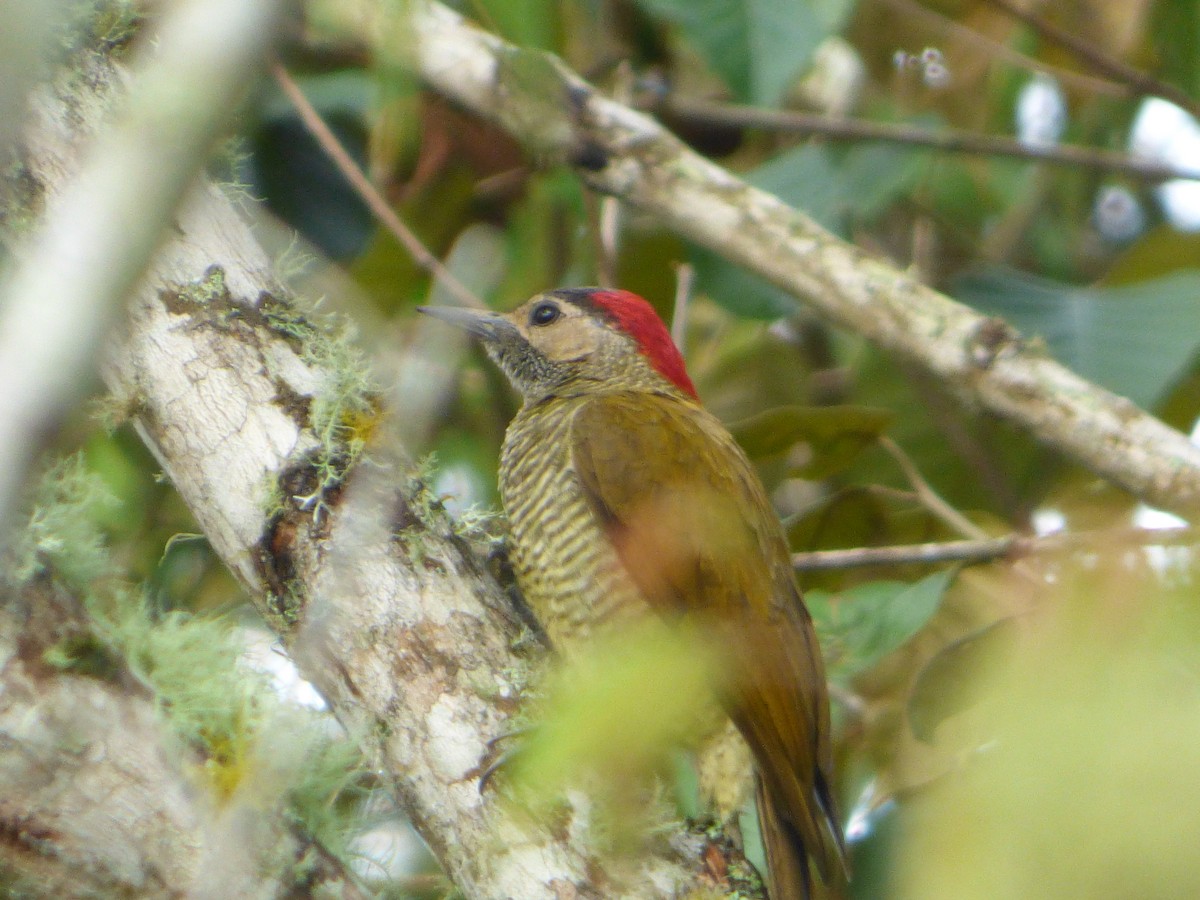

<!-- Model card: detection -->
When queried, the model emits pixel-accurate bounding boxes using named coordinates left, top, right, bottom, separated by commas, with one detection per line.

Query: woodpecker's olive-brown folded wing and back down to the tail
left=571, top=392, right=842, bottom=892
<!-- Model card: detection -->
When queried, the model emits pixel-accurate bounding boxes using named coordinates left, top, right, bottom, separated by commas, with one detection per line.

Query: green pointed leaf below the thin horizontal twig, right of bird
left=804, top=569, right=956, bottom=682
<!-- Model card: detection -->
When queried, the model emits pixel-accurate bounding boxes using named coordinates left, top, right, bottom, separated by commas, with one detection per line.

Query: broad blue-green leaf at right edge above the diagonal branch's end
left=955, top=268, right=1200, bottom=408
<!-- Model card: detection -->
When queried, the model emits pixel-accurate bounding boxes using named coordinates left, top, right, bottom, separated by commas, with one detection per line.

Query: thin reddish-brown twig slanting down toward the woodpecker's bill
left=271, top=62, right=485, bottom=308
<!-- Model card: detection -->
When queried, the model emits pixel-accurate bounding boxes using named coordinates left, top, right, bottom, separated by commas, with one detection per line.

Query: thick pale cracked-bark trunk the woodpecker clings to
left=7, top=28, right=745, bottom=900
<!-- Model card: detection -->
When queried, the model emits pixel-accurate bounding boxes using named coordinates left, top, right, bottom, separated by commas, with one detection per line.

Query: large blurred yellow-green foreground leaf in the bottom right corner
left=895, top=553, right=1200, bottom=900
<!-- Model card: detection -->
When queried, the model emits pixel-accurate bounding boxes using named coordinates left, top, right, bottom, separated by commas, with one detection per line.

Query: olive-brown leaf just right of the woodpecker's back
left=730, top=406, right=894, bottom=479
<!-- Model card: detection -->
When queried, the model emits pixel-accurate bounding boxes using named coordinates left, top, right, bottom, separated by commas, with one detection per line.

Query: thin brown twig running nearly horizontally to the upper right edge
left=659, top=97, right=1200, bottom=181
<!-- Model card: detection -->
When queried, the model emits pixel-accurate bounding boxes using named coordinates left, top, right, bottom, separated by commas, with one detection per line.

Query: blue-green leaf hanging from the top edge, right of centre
left=640, top=0, right=853, bottom=106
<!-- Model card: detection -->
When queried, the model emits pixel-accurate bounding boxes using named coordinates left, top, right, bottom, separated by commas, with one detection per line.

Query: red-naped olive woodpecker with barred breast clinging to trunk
left=422, top=288, right=846, bottom=900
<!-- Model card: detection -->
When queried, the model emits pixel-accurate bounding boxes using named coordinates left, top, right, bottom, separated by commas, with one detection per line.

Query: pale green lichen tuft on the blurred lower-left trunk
left=8, top=455, right=371, bottom=866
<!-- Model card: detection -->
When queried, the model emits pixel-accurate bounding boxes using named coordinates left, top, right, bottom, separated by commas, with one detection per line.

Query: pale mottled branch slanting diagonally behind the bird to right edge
left=344, top=0, right=1200, bottom=516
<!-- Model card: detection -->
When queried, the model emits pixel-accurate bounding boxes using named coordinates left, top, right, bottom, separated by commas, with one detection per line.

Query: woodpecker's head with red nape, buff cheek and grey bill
left=419, top=288, right=696, bottom=403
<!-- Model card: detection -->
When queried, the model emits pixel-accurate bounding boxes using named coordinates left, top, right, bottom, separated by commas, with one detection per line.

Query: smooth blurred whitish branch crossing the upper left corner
left=0, top=0, right=281, bottom=528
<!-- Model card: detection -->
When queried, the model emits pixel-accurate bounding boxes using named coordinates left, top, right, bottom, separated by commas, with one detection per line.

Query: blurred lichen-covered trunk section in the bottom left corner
left=0, top=575, right=361, bottom=900
